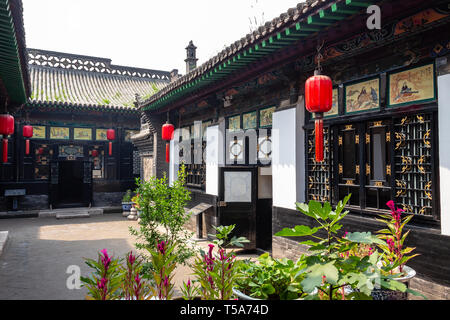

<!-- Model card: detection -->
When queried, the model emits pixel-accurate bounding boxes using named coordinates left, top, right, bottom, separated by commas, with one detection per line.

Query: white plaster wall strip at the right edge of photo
left=437, top=74, right=450, bottom=236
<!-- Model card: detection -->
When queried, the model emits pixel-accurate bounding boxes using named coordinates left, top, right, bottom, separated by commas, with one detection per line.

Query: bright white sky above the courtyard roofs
left=23, top=0, right=303, bottom=74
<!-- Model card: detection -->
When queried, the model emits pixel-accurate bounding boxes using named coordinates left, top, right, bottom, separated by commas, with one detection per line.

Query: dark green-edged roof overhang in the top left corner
left=0, top=0, right=31, bottom=104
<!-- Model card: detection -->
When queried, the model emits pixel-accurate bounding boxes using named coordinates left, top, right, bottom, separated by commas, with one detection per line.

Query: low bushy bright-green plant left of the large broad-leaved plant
left=236, top=253, right=305, bottom=300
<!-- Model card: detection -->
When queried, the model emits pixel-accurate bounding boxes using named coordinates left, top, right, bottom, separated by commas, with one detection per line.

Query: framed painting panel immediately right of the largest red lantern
left=344, top=77, right=380, bottom=114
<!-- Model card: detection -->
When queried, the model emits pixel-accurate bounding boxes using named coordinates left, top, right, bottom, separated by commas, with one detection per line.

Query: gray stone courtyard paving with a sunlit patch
left=0, top=213, right=255, bottom=300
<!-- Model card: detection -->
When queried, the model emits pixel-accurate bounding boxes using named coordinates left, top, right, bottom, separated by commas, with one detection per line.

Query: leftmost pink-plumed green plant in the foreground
left=80, top=249, right=122, bottom=300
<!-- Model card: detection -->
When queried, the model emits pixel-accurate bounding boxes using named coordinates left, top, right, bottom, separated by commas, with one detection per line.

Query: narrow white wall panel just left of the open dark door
left=205, top=125, right=220, bottom=196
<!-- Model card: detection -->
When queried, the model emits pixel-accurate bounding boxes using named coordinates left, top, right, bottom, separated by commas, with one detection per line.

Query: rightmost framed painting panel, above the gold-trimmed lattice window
left=388, top=63, right=436, bottom=107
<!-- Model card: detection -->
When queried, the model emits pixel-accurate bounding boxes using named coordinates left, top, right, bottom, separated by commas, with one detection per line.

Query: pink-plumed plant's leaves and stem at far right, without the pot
left=377, top=200, right=418, bottom=274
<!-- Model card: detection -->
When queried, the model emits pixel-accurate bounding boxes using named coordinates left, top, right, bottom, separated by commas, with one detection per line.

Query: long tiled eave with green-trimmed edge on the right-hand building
left=140, top=0, right=381, bottom=111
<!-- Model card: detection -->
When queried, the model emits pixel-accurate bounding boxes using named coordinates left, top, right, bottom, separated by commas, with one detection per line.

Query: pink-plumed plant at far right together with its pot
left=372, top=200, right=418, bottom=300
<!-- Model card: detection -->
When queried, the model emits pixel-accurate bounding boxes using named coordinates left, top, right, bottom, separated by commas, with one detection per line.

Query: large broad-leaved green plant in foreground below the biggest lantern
left=276, top=195, right=422, bottom=300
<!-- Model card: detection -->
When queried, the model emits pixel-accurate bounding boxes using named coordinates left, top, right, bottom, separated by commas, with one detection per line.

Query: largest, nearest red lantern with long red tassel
left=305, top=71, right=333, bottom=162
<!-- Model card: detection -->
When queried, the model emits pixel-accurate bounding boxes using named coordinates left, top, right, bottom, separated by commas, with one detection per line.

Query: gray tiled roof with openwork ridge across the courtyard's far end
left=28, top=49, right=170, bottom=109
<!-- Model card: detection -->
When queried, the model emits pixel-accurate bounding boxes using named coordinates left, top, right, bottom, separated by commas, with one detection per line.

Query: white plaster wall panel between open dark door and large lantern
left=272, top=108, right=303, bottom=209
